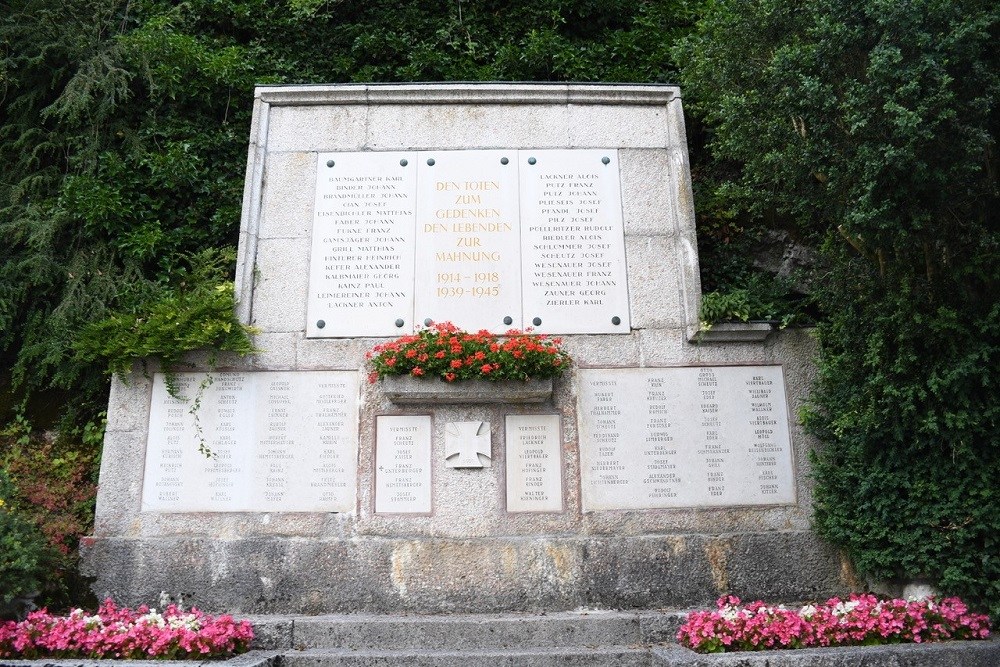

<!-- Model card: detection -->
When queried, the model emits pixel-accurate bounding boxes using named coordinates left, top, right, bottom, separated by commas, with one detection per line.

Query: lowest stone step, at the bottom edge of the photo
left=281, top=646, right=651, bottom=667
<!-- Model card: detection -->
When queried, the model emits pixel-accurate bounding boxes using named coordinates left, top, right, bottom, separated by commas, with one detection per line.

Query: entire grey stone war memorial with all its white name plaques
left=84, top=84, right=850, bottom=613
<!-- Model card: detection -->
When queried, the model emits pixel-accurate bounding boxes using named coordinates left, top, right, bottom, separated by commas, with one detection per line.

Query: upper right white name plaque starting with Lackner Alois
left=519, top=150, right=630, bottom=334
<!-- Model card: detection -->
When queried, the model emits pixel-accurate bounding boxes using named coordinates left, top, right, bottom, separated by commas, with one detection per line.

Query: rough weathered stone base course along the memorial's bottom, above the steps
left=85, top=532, right=846, bottom=614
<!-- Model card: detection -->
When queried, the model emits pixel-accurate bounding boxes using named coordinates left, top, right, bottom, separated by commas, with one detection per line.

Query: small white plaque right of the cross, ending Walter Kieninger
left=505, top=415, right=563, bottom=512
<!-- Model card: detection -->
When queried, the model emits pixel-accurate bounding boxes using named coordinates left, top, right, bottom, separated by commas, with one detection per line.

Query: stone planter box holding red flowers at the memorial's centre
left=381, top=375, right=552, bottom=405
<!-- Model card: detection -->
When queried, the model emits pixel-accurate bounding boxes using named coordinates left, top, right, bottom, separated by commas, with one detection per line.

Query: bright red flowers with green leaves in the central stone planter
left=366, top=322, right=570, bottom=382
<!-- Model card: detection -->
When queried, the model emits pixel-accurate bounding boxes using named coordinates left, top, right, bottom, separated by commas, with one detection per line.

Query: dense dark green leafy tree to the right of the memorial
left=677, top=0, right=1000, bottom=612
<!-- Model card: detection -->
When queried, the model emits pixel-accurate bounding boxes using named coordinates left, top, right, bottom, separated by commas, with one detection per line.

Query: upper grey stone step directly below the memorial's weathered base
left=251, top=611, right=683, bottom=651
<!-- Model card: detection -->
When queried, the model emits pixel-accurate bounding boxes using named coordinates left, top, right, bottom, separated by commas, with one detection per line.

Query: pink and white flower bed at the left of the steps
left=0, top=600, right=253, bottom=659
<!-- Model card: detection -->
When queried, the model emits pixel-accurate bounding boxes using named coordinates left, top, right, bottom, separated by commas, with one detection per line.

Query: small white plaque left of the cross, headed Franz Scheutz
left=375, top=415, right=431, bottom=514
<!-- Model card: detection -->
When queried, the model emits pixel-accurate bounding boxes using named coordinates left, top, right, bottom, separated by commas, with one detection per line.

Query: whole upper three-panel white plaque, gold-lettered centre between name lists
left=306, top=149, right=630, bottom=338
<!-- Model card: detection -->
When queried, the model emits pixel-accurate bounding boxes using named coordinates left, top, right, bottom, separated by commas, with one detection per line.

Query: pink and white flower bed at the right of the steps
left=677, top=594, right=990, bottom=653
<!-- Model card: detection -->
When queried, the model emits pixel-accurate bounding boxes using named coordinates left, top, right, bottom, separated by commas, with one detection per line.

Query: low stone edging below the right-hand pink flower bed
left=652, top=639, right=1000, bottom=667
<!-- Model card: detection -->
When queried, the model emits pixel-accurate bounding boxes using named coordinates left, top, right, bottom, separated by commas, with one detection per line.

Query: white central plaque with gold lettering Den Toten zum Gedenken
left=414, top=151, right=521, bottom=333
